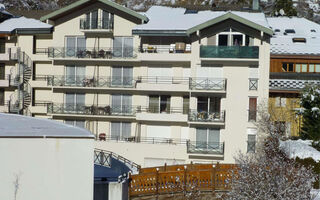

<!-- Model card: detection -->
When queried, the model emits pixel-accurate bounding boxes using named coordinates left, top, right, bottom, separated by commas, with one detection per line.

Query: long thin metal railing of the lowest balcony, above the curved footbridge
left=96, top=134, right=188, bottom=145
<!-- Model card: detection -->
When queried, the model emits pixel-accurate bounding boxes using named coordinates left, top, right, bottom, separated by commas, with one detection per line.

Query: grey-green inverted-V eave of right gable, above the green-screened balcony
left=187, top=12, right=273, bottom=36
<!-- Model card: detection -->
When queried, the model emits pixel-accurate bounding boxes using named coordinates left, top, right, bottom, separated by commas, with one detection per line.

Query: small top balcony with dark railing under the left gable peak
left=80, top=18, right=113, bottom=33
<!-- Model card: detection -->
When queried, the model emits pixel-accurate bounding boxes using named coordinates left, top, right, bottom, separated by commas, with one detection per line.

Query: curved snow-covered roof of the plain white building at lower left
left=0, top=113, right=94, bottom=139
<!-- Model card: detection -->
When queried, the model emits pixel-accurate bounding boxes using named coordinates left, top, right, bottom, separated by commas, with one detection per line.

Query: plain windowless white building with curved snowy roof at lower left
left=0, top=113, right=94, bottom=200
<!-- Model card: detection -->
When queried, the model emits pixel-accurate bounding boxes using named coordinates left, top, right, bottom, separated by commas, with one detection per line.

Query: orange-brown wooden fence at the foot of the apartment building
left=129, top=164, right=236, bottom=196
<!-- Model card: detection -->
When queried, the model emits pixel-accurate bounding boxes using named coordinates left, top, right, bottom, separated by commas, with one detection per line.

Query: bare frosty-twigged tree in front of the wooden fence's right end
left=226, top=105, right=315, bottom=200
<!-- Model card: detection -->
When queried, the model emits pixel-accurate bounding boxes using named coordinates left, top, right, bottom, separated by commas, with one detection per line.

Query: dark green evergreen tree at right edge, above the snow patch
left=300, top=85, right=320, bottom=144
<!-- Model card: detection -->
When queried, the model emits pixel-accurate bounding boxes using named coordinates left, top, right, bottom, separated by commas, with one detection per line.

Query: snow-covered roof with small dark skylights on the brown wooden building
left=267, top=17, right=320, bottom=55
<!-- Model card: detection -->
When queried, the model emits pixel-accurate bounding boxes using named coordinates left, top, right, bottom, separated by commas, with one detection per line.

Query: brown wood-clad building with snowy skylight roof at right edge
left=268, top=17, right=320, bottom=136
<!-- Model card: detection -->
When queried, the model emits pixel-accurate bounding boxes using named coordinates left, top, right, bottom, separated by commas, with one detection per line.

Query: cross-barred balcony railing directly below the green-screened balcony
left=189, top=78, right=227, bottom=91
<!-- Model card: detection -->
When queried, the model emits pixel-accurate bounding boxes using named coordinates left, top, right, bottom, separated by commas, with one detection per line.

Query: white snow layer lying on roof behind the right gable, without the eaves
left=134, top=6, right=269, bottom=34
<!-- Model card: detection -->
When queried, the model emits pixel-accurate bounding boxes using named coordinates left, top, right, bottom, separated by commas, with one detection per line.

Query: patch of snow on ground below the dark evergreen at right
left=280, top=140, right=320, bottom=162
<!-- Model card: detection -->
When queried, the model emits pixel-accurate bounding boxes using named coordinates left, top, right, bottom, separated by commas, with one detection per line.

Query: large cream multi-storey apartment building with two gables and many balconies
left=0, top=0, right=273, bottom=166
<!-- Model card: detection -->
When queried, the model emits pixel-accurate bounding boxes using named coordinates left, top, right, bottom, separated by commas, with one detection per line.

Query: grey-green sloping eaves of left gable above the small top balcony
left=40, top=0, right=148, bottom=22
